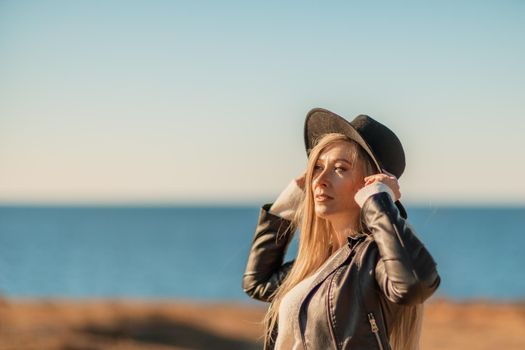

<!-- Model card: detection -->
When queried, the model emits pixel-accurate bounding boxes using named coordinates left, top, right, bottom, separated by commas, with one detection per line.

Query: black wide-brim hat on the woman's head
left=304, top=108, right=407, bottom=218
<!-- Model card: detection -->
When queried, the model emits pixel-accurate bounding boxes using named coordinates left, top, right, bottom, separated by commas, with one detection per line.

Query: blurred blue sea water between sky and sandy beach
left=0, top=206, right=525, bottom=301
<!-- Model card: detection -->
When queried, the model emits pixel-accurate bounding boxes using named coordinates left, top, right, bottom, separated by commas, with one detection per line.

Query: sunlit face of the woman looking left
left=312, top=141, right=364, bottom=221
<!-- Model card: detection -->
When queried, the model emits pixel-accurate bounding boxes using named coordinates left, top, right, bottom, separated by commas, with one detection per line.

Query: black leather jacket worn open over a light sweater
left=243, top=192, right=440, bottom=350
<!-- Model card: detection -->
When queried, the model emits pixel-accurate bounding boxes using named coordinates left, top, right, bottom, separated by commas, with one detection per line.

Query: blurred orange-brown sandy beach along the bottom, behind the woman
left=0, top=299, right=525, bottom=350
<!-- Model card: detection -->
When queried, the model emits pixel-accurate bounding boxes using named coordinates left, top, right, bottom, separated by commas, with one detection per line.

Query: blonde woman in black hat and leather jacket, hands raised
left=243, top=108, right=440, bottom=350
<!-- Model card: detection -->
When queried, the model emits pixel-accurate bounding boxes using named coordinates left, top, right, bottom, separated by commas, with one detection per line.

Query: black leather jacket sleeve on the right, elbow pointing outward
left=361, top=192, right=441, bottom=305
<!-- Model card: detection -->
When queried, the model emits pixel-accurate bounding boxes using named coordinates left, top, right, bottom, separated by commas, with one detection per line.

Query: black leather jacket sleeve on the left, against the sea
left=242, top=204, right=295, bottom=301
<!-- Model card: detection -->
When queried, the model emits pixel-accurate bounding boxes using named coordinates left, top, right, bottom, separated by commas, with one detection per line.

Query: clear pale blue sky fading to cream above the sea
left=0, top=0, right=525, bottom=204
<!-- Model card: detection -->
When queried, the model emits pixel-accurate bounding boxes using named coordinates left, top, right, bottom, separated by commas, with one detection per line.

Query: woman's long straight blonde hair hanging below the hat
left=263, top=133, right=422, bottom=350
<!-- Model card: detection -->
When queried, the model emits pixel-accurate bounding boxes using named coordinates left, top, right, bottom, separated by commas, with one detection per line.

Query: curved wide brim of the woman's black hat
left=304, top=108, right=407, bottom=219
